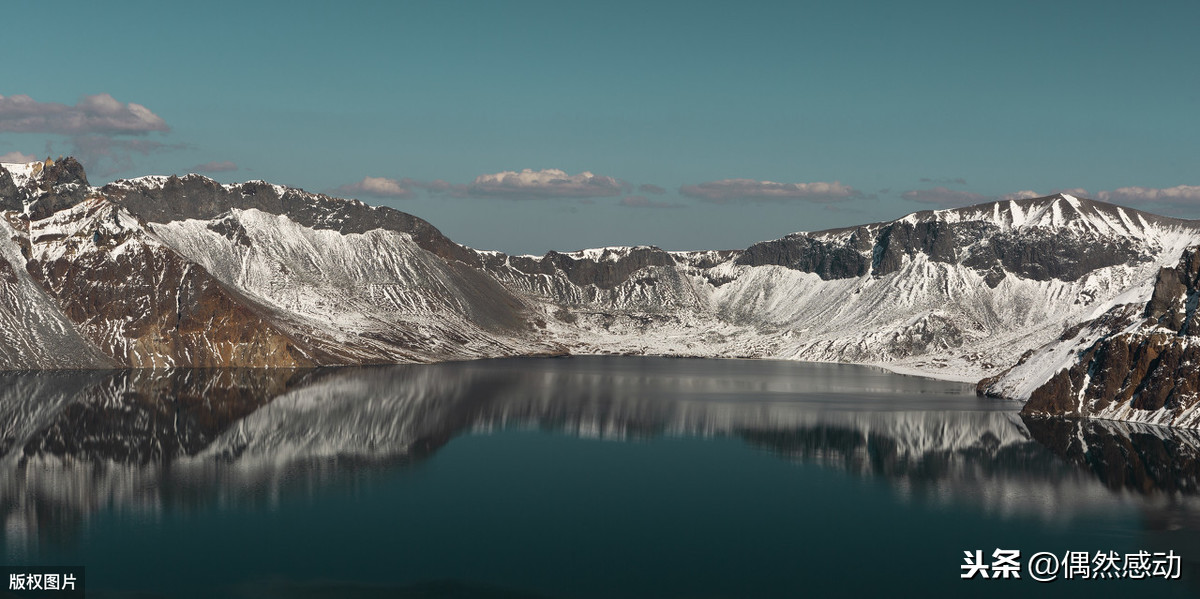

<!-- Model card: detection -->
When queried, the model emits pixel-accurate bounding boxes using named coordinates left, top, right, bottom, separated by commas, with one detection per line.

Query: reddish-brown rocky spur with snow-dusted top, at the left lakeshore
left=18, top=198, right=336, bottom=367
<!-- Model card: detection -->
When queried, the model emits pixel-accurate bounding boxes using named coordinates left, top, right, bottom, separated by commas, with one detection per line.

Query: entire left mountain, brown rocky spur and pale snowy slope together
left=0, top=158, right=558, bottom=369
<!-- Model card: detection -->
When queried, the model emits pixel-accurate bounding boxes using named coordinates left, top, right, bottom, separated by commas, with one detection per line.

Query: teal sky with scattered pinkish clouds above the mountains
left=0, top=0, right=1200, bottom=254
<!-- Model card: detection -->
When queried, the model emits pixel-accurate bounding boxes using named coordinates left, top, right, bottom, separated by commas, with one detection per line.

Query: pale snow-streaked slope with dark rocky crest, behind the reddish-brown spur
left=102, top=175, right=554, bottom=364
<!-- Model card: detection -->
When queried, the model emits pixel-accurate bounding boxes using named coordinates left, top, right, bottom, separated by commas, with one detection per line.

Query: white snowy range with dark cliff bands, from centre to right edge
left=481, top=196, right=1198, bottom=382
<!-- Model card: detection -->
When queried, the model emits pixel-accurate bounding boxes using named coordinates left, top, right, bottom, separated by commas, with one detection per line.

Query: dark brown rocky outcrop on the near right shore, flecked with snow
left=1022, top=247, right=1200, bottom=426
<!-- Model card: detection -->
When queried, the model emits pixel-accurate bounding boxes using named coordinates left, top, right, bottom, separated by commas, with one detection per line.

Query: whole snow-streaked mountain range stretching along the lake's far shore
left=0, top=158, right=1200, bottom=427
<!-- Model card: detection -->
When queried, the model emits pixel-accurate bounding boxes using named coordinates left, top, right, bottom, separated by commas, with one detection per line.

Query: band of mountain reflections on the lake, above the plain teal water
left=7, top=358, right=1200, bottom=549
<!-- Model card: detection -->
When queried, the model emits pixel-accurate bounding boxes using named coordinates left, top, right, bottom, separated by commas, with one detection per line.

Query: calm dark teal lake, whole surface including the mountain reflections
left=0, top=358, right=1200, bottom=598
